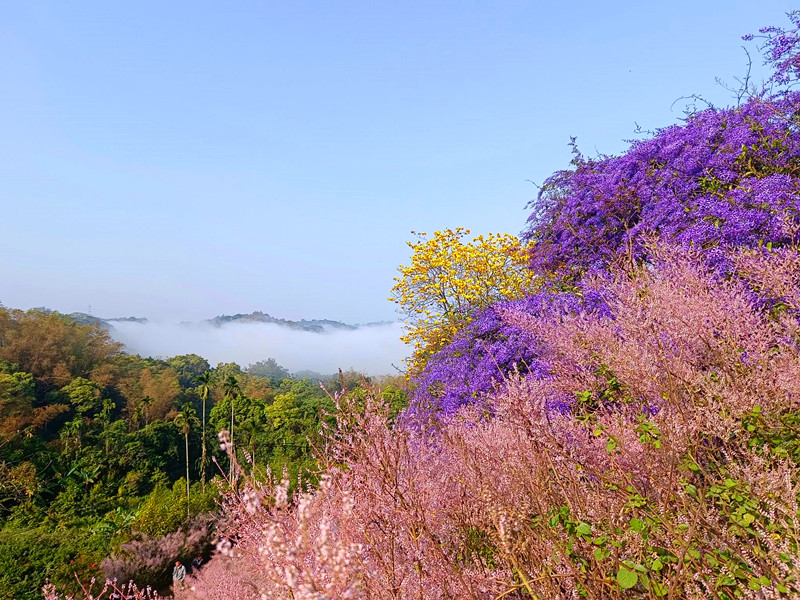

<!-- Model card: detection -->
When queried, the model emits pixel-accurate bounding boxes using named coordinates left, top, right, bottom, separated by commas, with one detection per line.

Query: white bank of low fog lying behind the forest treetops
left=111, top=321, right=407, bottom=375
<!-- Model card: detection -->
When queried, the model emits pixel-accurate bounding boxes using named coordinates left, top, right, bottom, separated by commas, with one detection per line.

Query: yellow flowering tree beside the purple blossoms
left=389, top=227, right=534, bottom=373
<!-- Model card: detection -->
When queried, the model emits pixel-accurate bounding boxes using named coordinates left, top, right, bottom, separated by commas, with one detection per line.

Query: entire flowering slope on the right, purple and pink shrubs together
left=47, top=9, right=800, bottom=600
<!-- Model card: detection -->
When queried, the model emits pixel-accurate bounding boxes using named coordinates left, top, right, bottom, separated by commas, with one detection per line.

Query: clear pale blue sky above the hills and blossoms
left=0, top=0, right=792, bottom=322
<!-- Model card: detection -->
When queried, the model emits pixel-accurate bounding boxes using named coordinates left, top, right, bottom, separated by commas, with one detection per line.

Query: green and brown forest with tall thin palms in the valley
left=0, top=308, right=404, bottom=599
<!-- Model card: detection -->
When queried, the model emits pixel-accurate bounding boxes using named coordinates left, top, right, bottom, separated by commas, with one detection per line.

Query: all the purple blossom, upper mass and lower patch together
left=412, top=84, right=800, bottom=416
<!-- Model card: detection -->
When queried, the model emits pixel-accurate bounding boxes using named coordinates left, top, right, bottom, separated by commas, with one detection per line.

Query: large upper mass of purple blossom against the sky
left=523, top=93, right=800, bottom=278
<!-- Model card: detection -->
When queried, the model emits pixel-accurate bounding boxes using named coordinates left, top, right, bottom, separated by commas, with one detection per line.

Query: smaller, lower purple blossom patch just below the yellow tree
left=408, top=290, right=611, bottom=421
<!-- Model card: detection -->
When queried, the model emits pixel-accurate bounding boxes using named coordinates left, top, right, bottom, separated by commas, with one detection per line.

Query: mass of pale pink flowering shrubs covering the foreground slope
left=180, top=249, right=800, bottom=600
